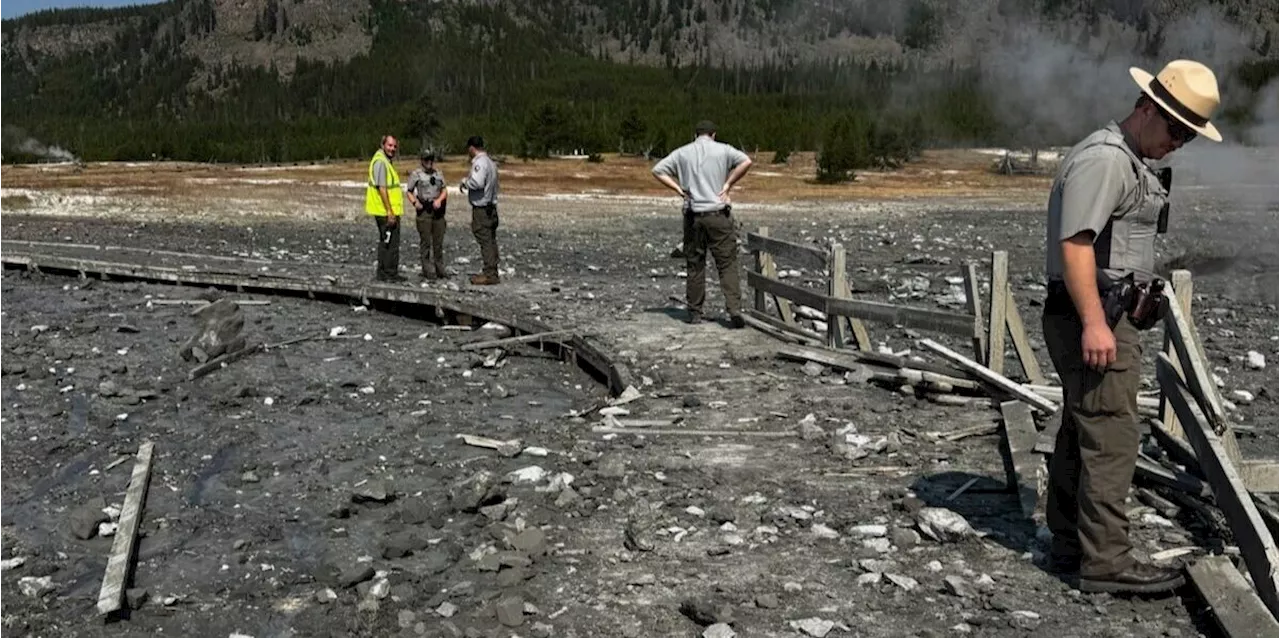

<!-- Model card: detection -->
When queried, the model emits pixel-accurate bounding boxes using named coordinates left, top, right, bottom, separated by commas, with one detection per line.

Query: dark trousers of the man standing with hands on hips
left=684, top=210, right=742, bottom=315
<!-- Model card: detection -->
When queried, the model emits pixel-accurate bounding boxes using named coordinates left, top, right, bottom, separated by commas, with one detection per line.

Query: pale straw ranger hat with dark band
left=1129, top=60, right=1222, bottom=142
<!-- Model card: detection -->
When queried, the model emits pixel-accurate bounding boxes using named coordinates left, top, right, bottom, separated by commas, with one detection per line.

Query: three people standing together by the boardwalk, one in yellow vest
left=365, top=135, right=500, bottom=286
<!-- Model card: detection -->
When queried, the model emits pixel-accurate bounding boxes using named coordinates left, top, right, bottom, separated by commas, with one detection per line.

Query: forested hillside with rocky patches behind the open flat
left=0, top=0, right=1276, bottom=163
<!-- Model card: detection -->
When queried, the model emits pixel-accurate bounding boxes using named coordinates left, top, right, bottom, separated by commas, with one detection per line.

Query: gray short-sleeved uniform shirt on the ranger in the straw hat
left=1044, top=122, right=1169, bottom=288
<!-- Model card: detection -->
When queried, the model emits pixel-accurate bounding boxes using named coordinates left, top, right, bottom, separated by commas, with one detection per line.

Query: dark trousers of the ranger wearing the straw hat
left=1043, top=293, right=1142, bottom=578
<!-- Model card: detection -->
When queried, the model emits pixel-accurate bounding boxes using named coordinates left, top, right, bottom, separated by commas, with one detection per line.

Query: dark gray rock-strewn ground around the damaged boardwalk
left=0, top=165, right=1280, bottom=638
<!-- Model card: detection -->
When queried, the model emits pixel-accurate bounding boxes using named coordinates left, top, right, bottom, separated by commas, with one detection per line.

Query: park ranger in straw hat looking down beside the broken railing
left=1043, top=60, right=1222, bottom=593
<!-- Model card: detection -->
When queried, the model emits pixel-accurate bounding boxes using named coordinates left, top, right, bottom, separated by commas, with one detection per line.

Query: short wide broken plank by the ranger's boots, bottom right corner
left=1187, top=556, right=1280, bottom=638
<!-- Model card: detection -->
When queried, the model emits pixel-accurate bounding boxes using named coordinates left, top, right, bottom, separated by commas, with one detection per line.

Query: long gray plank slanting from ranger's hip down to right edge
left=1156, top=353, right=1280, bottom=618
